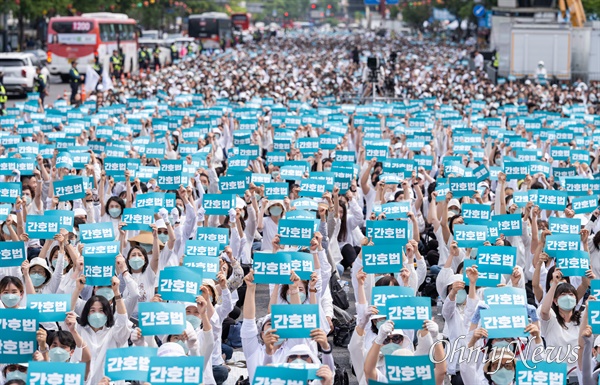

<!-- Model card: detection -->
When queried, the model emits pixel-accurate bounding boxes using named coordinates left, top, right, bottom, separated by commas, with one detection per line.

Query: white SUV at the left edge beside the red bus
left=0, top=52, right=40, bottom=95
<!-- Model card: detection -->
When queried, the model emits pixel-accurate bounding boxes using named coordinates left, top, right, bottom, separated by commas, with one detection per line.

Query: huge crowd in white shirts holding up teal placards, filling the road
left=0, top=33, right=600, bottom=385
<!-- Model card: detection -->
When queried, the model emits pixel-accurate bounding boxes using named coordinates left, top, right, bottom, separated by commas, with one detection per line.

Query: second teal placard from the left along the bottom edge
left=104, top=346, right=157, bottom=382
